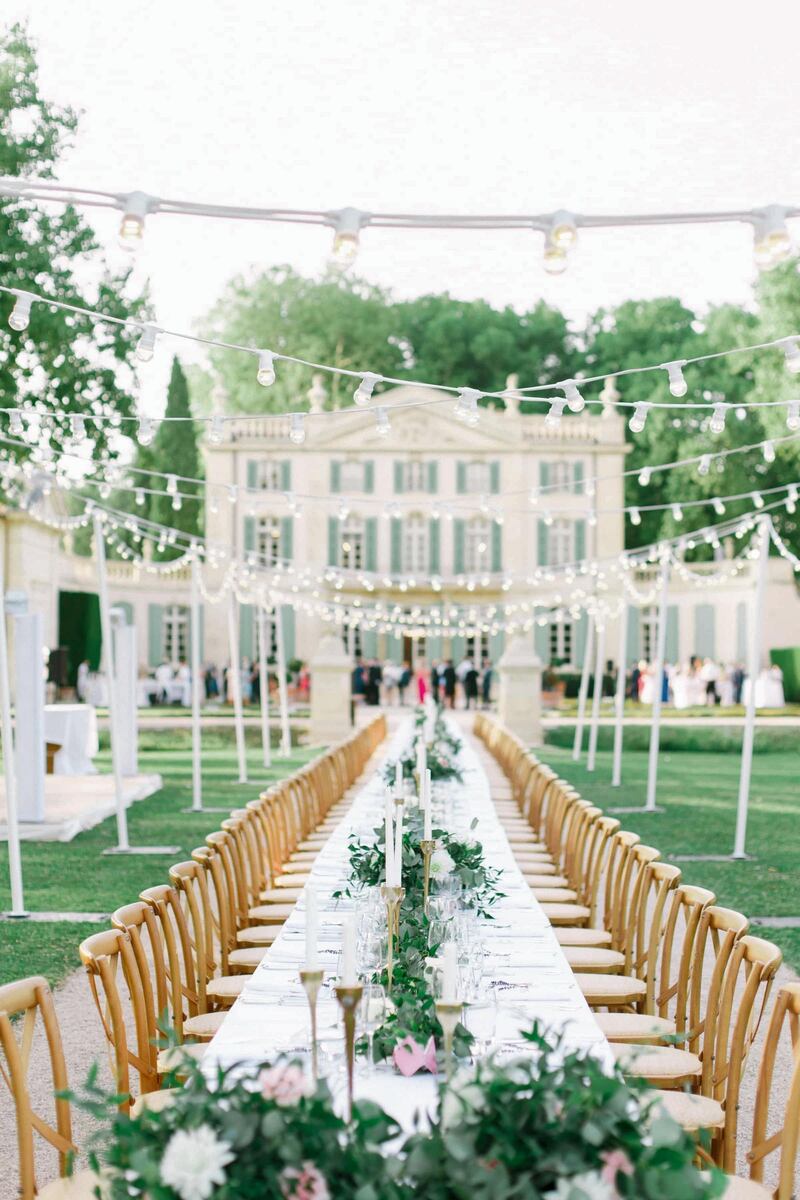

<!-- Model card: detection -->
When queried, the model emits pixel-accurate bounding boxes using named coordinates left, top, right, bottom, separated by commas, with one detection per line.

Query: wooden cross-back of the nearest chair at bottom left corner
left=0, top=976, right=76, bottom=1200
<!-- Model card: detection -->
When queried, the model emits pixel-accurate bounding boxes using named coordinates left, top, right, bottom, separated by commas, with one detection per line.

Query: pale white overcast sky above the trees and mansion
left=2, top=0, right=800, bottom=402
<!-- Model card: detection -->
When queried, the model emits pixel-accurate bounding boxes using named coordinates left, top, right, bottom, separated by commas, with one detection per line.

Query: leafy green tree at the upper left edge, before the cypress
left=0, top=25, right=144, bottom=482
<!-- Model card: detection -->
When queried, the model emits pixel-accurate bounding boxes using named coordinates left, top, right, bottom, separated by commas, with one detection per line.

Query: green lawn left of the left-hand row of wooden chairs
left=0, top=731, right=315, bottom=983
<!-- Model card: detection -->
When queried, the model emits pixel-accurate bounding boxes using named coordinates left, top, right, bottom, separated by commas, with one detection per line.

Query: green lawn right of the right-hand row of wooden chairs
left=541, top=730, right=800, bottom=970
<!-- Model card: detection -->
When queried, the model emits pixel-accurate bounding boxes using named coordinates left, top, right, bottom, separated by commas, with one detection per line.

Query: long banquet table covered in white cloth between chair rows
left=203, top=720, right=610, bottom=1132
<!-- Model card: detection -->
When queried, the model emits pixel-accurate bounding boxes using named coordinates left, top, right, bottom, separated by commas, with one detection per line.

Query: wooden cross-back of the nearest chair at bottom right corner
left=747, top=983, right=800, bottom=1200
